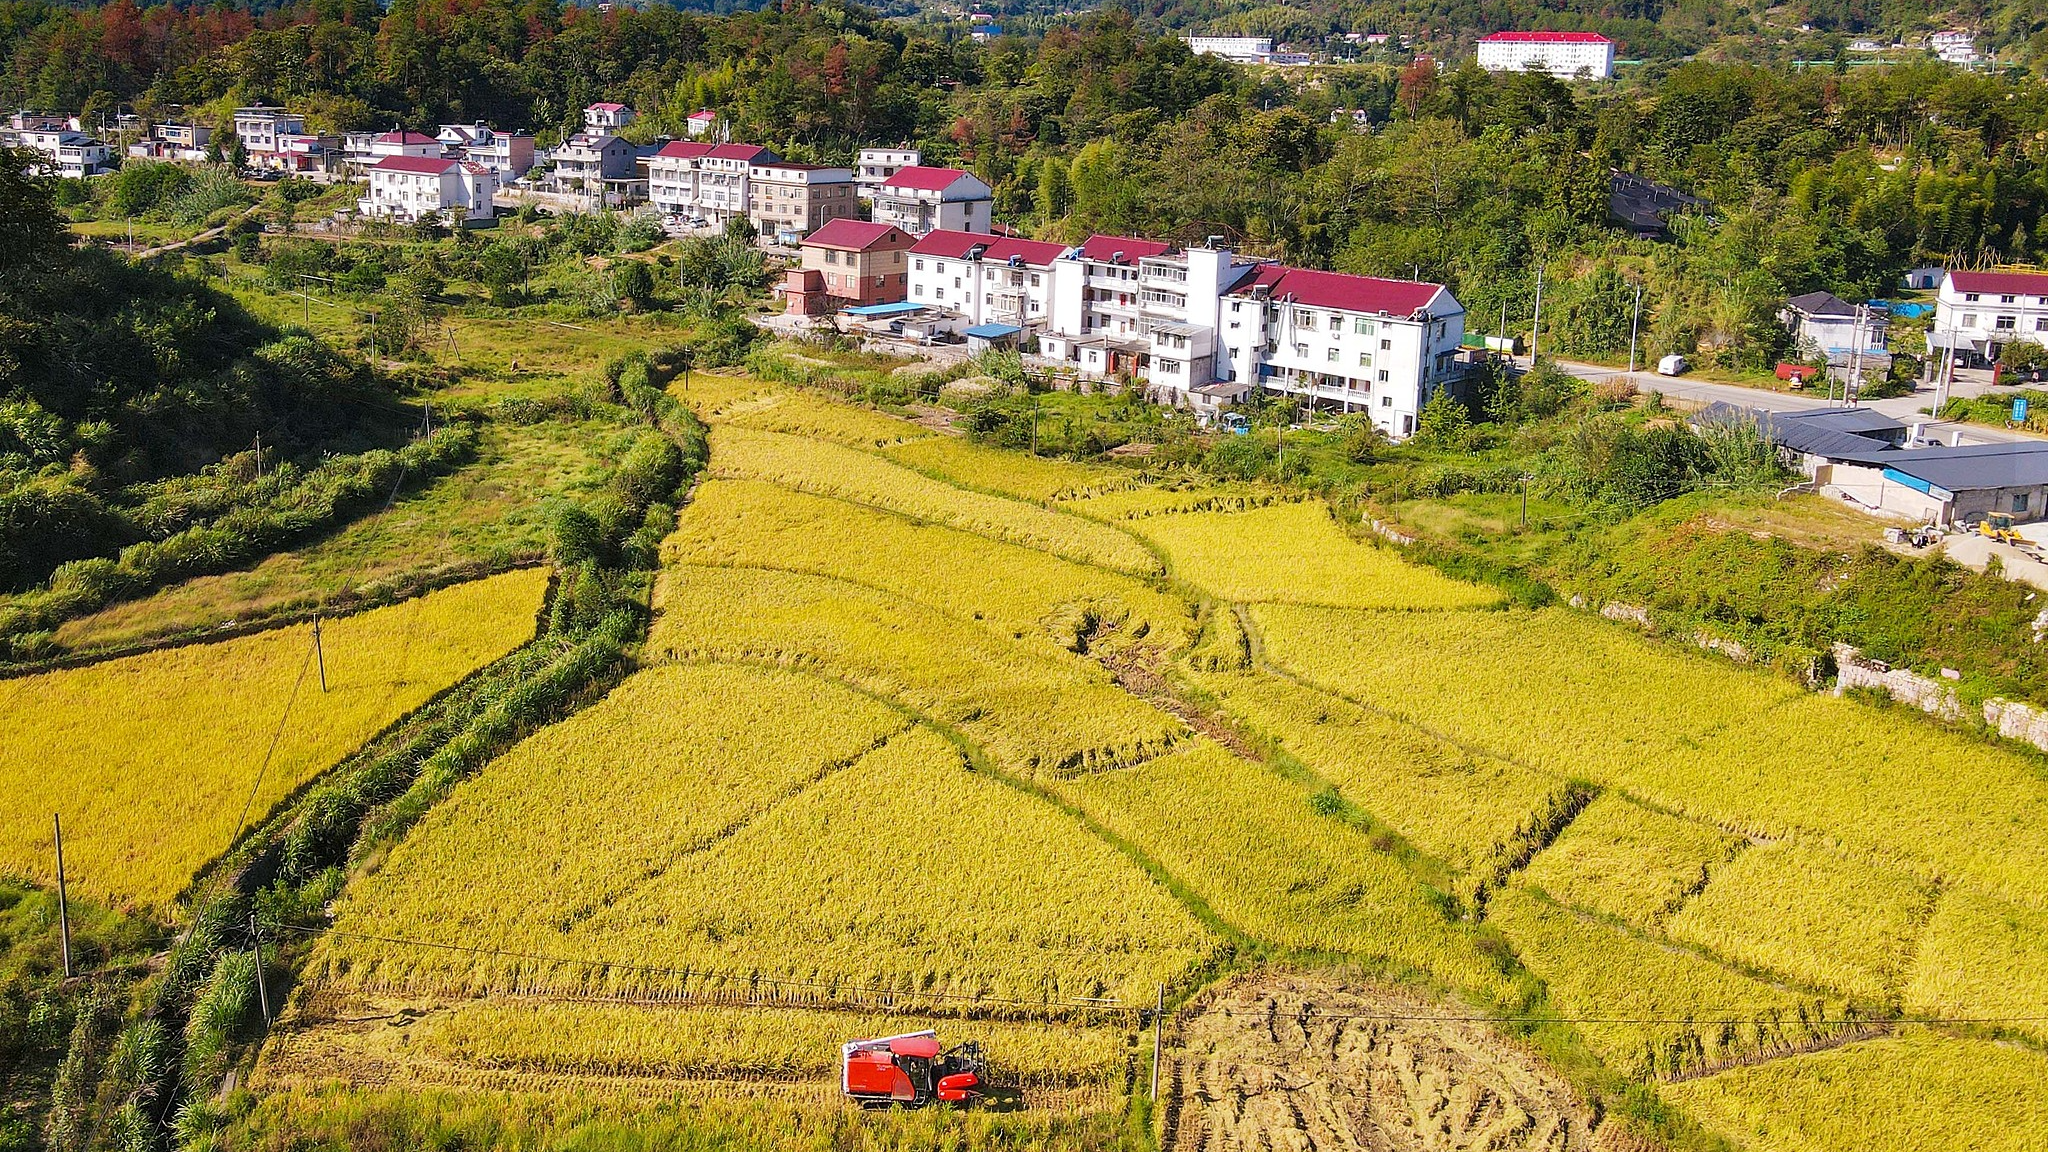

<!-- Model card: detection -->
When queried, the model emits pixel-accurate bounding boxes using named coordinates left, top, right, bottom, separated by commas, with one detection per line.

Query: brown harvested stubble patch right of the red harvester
left=1161, top=972, right=1638, bottom=1152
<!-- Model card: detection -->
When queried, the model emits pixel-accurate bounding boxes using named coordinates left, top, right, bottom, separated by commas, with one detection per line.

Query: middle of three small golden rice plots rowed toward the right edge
left=1667, top=842, right=1933, bottom=1000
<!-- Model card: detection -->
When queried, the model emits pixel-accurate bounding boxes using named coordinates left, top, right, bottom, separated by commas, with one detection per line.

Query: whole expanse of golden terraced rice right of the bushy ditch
left=262, top=377, right=2048, bottom=1152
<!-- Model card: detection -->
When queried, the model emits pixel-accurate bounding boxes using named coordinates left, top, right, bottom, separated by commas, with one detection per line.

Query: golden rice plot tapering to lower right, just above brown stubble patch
left=1059, top=740, right=1499, bottom=988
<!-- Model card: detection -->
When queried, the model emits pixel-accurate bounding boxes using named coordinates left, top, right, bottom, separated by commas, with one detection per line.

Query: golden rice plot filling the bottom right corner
left=1659, top=1029, right=2048, bottom=1152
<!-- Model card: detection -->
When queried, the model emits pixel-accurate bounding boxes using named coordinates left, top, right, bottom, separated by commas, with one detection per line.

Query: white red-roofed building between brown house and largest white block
left=913, top=221, right=1067, bottom=334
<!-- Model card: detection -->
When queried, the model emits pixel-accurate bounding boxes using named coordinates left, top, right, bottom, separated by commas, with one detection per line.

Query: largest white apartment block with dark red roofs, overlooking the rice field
left=1048, top=236, right=1464, bottom=439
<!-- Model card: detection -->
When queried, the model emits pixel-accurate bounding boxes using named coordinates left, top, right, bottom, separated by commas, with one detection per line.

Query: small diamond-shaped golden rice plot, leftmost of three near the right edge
left=1522, top=791, right=1743, bottom=929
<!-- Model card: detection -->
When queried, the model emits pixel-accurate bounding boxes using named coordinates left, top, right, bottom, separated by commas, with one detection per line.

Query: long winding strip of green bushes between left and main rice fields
left=18, top=344, right=707, bottom=1152
